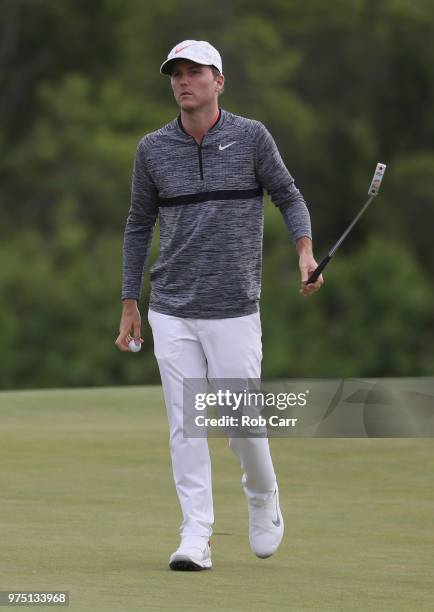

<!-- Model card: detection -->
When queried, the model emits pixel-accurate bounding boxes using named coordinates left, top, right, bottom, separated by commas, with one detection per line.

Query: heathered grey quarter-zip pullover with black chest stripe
left=122, top=110, right=311, bottom=319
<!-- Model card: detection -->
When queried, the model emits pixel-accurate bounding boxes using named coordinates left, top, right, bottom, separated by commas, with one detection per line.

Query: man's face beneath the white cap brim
left=170, top=60, right=224, bottom=110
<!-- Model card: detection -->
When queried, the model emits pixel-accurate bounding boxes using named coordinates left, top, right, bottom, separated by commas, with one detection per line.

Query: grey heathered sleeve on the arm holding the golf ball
left=122, top=141, right=158, bottom=300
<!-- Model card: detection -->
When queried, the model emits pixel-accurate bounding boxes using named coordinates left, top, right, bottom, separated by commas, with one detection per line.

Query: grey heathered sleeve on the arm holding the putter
left=256, top=122, right=312, bottom=243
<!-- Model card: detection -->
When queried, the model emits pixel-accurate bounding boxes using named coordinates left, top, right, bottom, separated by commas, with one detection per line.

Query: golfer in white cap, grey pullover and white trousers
left=116, top=40, right=323, bottom=570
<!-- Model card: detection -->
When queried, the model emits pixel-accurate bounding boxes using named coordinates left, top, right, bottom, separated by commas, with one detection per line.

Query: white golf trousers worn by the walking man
left=148, top=310, right=276, bottom=536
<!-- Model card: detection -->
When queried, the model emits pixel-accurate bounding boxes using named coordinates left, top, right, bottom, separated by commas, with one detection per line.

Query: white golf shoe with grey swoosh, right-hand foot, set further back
left=247, top=485, right=284, bottom=559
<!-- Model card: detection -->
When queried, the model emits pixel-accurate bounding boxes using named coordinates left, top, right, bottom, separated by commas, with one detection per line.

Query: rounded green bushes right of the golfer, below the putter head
left=262, top=205, right=434, bottom=378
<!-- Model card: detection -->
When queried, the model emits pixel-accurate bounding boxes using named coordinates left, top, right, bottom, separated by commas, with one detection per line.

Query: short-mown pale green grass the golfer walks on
left=0, top=387, right=434, bottom=612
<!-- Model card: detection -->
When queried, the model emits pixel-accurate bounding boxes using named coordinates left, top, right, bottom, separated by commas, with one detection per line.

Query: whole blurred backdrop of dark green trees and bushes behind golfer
left=0, top=0, right=434, bottom=388
